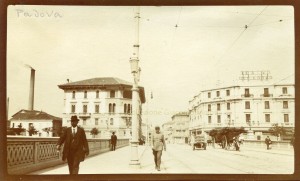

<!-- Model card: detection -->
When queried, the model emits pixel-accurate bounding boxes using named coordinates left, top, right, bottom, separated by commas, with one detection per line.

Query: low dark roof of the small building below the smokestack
left=10, top=109, right=62, bottom=121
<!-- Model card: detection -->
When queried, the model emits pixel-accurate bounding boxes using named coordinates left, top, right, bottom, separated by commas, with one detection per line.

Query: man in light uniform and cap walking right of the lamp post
left=151, top=126, right=166, bottom=171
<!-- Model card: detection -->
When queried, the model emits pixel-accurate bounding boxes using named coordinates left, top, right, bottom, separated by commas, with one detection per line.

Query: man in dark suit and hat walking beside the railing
left=56, top=116, right=89, bottom=174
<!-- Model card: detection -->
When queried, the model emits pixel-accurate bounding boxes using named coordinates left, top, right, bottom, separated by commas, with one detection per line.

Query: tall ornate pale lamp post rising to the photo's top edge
left=129, top=7, right=141, bottom=168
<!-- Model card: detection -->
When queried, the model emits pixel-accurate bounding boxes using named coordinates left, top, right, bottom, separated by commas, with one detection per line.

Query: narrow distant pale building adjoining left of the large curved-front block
left=172, top=112, right=189, bottom=143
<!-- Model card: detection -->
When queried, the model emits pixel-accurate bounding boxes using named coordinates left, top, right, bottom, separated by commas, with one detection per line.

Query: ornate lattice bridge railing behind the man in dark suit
left=6, top=136, right=129, bottom=175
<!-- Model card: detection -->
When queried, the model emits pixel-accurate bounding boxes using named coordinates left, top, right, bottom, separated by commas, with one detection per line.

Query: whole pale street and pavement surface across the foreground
left=31, top=144, right=294, bottom=175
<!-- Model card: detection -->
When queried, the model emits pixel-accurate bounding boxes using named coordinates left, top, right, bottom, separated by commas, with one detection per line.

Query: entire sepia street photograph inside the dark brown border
left=6, top=2, right=296, bottom=179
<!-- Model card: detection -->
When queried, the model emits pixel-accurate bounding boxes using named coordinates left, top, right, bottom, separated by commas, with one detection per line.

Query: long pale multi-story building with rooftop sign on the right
left=189, top=83, right=295, bottom=140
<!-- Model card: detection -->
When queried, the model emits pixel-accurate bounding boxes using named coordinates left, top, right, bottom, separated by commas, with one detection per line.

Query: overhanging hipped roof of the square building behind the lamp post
left=58, top=77, right=146, bottom=103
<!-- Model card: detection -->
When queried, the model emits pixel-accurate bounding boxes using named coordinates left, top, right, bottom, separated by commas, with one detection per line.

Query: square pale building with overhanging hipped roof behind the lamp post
left=58, top=77, right=145, bottom=138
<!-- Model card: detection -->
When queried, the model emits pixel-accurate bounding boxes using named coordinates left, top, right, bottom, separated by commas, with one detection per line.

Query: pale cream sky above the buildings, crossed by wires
left=7, top=5, right=295, bottom=125
